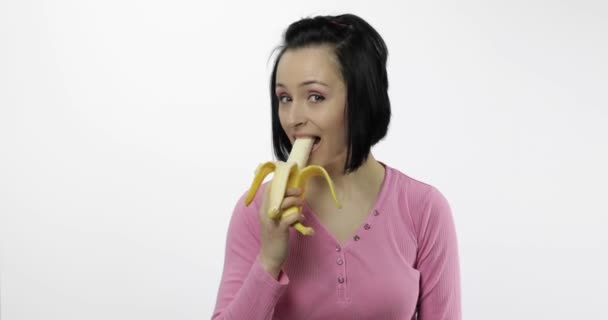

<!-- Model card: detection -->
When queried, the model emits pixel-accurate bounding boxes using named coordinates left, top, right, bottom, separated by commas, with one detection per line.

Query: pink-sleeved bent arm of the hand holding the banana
left=212, top=188, right=289, bottom=320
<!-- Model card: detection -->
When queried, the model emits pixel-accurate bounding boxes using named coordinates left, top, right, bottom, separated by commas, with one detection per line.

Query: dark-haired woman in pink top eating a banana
left=213, top=14, right=461, bottom=320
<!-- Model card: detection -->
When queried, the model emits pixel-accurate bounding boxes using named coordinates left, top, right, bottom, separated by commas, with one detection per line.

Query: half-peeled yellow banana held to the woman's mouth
left=245, top=137, right=341, bottom=235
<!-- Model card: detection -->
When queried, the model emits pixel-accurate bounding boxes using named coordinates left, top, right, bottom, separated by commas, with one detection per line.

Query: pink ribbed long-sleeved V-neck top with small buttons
left=212, top=163, right=461, bottom=320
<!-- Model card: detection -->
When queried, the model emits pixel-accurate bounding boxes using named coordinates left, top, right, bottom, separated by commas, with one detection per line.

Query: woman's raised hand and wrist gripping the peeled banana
left=259, top=184, right=304, bottom=279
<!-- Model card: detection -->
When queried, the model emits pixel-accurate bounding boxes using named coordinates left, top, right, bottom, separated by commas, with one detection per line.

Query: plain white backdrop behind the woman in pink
left=0, top=0, right=608, bottom=320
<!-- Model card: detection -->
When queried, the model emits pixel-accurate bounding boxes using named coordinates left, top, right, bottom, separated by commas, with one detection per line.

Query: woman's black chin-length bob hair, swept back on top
left=270, top=14, right=391, bottom=173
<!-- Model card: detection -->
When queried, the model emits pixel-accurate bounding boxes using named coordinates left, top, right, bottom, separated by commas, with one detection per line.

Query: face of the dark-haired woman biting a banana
left=275, top=45, right=347, bottom=169
